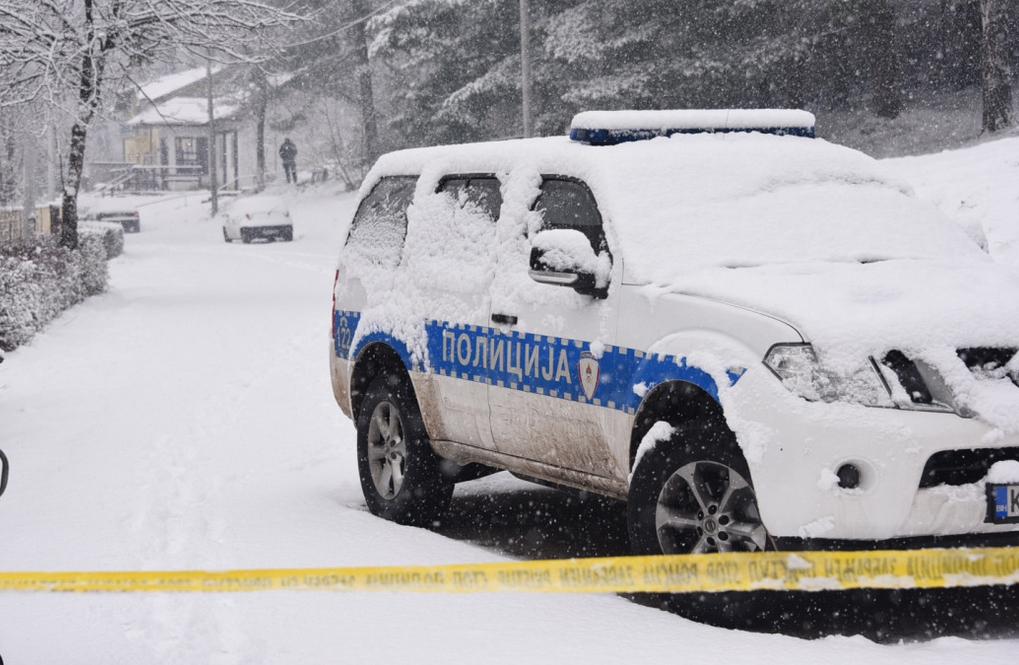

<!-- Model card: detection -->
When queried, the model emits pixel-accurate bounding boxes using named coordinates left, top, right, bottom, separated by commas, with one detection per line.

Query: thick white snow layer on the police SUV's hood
left=672, top=260, right=1019, bottom=433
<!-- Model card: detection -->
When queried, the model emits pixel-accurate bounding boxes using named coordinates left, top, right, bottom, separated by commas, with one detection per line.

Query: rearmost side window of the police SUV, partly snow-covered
left=346, top=176, right=417, bottom=268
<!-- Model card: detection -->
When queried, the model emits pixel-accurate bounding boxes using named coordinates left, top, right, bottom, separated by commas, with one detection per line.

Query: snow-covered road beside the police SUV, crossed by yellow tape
left=0, top=189, right=1019, bottom=665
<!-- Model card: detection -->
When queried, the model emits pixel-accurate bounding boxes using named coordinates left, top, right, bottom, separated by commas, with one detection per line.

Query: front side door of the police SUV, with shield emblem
left=489, top=175, right=626, bottom=480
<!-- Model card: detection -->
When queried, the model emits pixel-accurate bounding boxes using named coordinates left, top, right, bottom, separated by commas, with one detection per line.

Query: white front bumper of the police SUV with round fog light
left=723, top=368, right=1019, bottom=543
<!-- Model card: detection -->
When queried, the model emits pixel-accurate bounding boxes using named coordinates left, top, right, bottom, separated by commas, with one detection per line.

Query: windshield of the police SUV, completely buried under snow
left=589, top=134, right=983, bottom=282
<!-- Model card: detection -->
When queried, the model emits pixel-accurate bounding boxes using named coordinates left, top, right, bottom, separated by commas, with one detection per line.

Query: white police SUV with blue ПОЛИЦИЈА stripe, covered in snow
left=331, top=110, right=1019, bottom=553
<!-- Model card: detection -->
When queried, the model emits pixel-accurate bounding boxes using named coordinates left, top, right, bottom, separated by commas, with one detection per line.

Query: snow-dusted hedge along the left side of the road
left=0, top=233, right=109, bottom=351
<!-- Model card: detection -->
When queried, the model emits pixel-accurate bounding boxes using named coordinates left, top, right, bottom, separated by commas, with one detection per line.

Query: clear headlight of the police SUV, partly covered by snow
left=764, top=344, right=895, bottom=406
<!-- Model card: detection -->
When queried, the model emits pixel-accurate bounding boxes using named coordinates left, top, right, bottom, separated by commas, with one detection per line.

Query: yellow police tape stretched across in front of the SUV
left=0, top=548, right=1019, bottom=594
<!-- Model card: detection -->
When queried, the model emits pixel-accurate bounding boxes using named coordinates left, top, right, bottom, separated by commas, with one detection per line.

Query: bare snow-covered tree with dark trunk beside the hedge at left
left=0, top=0, right=298, bottom=247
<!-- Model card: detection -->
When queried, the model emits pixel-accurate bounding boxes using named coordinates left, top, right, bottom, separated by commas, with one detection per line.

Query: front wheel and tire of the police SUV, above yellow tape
left=627, top=421, right=774, bottom=554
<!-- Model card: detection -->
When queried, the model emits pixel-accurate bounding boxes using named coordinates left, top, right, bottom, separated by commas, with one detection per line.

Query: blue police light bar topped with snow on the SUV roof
left=570, top=109, right=815, bottom=146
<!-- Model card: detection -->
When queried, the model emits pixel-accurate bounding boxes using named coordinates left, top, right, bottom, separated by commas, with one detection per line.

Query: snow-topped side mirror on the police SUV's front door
left=530, top=229, right=611, bottom=298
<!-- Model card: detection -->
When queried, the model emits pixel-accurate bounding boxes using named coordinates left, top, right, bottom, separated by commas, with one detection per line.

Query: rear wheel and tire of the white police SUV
left=358, top=376, right=453, bottom=527
